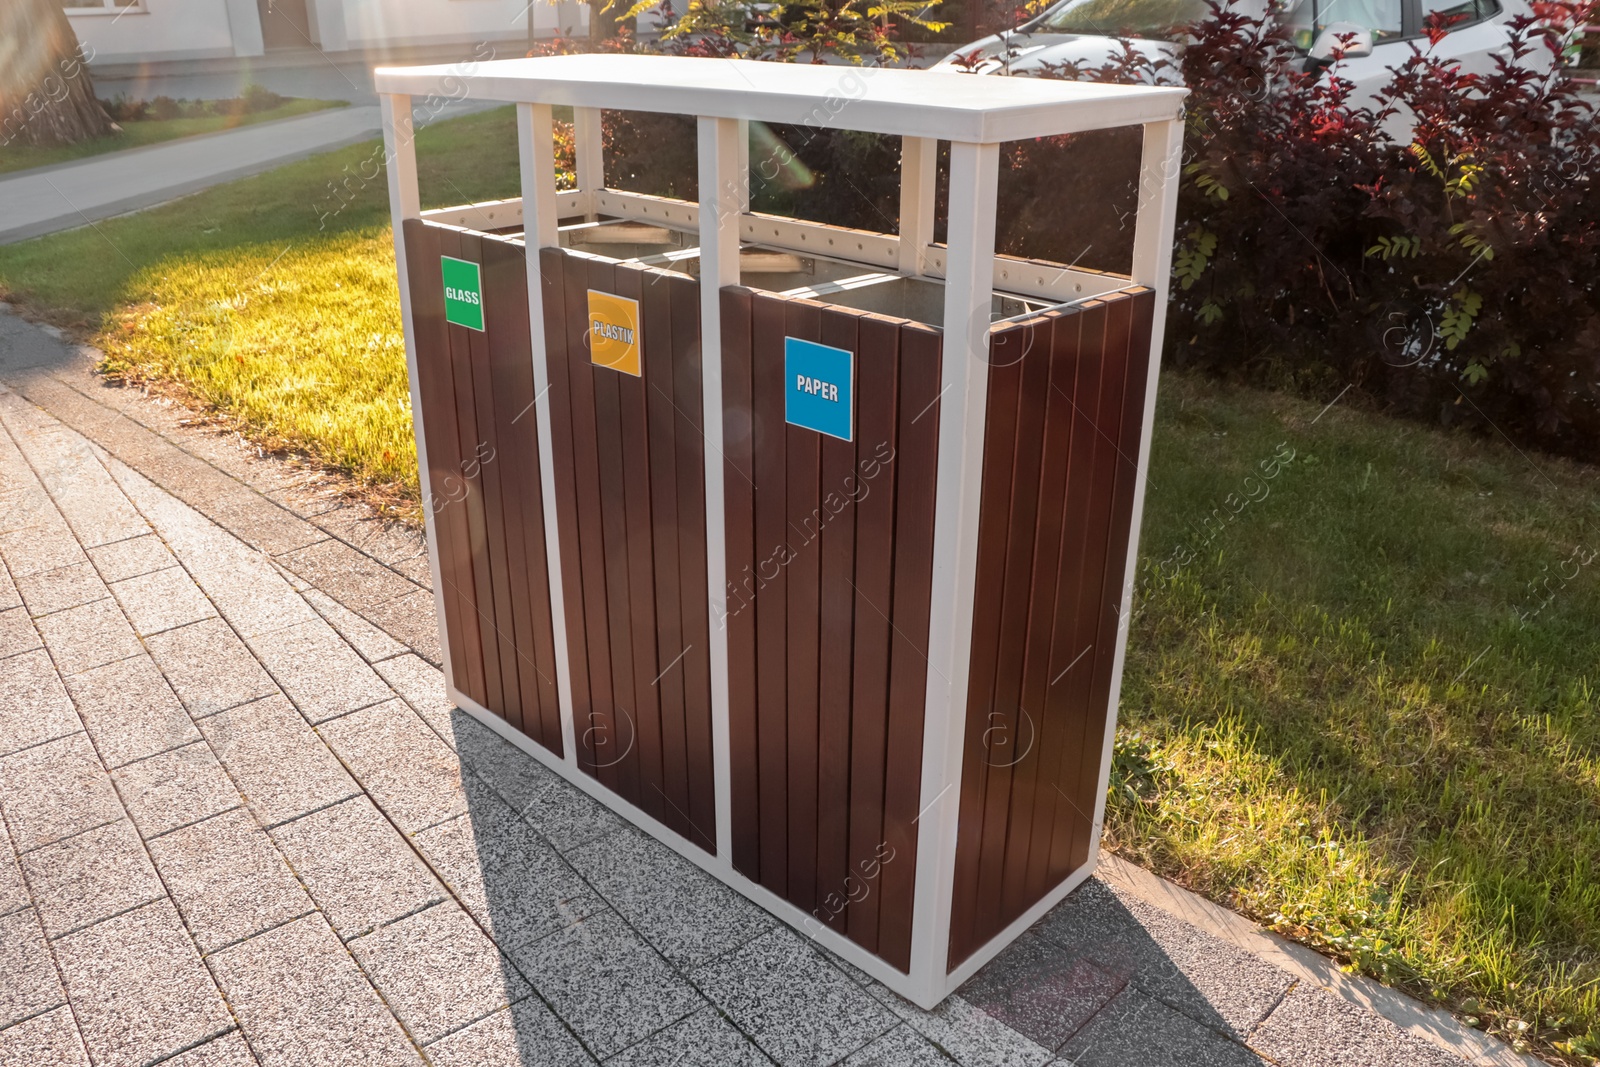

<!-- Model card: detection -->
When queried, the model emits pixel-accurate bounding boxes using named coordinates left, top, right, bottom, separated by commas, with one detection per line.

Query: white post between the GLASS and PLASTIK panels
left=517, top=104, right=578, bottom=768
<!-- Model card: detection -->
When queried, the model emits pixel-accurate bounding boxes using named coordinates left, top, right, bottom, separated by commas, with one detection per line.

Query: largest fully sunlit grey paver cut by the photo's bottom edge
left=211, top=913, right=421, bottom=1067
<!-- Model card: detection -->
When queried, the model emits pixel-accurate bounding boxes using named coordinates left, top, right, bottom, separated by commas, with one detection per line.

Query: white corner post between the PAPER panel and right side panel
left=910, top=135, right=1000, bottom=1003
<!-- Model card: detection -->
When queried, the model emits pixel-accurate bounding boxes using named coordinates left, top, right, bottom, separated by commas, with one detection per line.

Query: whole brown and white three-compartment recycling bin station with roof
left=376, top=54, right=1186, bottom=1008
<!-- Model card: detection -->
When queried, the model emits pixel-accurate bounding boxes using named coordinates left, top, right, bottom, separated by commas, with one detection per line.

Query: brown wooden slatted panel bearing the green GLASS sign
left=405, top=219, right=562, bottom=755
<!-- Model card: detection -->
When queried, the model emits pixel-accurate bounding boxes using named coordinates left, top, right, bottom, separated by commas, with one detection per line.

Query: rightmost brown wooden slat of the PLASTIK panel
left=667, top=275, right=717, bottom=851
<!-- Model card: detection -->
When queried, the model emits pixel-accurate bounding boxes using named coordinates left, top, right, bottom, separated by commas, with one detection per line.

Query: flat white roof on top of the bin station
left=376, top=56, right=1189, bottom=144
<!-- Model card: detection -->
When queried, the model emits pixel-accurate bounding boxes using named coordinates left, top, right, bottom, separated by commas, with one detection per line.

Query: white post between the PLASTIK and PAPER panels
left=699, top=118, right=747, bottom=864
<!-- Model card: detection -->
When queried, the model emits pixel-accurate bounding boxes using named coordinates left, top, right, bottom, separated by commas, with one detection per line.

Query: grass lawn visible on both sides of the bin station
left=0, top=103, right=1600, bottom=1064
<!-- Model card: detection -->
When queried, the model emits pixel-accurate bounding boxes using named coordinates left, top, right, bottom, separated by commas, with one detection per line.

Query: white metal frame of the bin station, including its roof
left=376, top=56, right=1184, bottom=1008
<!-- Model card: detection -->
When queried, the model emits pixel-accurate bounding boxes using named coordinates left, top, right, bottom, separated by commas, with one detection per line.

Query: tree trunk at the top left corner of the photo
left=0, top=0, right=114, bottom=146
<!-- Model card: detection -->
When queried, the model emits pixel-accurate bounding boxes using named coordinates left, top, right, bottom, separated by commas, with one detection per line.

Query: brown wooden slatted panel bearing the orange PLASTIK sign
left=539, top=248, right=717, bottom=851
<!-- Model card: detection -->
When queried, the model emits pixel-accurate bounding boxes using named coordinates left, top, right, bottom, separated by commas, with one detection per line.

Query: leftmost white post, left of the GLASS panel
left=378, top=93, right=461, bottom=688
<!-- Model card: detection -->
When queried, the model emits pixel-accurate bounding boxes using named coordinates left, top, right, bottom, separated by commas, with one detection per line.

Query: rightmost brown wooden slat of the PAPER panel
left=878, top=323, right=955, bottom=971
